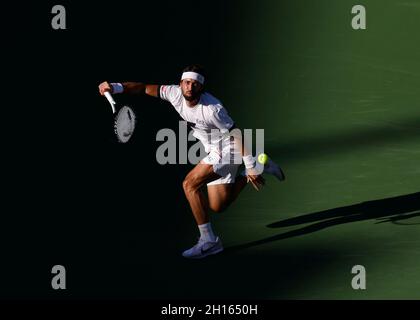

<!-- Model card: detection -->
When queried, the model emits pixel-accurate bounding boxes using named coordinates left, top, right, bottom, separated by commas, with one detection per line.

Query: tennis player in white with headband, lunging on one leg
left=99, top=65, right=285, bottom=259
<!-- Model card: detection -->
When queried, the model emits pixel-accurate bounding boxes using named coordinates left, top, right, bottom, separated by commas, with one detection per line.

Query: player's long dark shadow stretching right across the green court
left=226, top=192, right=420, bottom=251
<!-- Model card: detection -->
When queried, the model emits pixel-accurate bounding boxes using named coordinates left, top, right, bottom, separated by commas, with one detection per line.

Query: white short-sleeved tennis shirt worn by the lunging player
left=159, top=85, right=234, bottom=153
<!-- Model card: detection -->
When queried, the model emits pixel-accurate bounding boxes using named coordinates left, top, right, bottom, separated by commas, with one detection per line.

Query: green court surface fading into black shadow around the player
left=4, top=0, right=420, bottom=299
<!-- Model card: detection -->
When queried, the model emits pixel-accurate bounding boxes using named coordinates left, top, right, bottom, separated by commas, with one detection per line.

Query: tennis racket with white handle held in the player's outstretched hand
left=104, top=91, right=136, bottom=143
